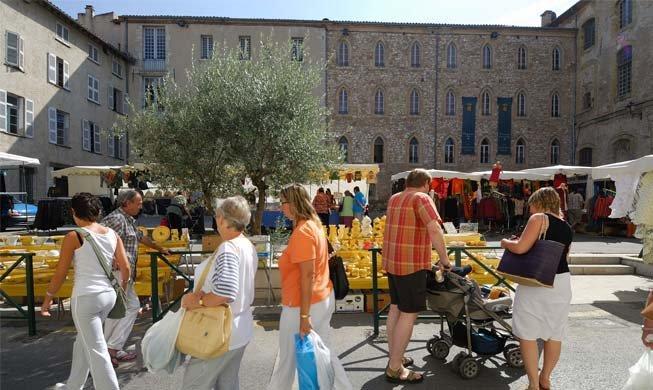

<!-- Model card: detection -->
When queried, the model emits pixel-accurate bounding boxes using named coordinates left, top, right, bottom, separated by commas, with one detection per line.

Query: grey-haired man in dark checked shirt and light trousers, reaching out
left=102, top=190, right=170, bottom=367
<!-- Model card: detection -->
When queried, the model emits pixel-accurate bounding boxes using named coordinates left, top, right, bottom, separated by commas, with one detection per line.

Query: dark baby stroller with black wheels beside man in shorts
left=426, top=272, right=524, bottom=379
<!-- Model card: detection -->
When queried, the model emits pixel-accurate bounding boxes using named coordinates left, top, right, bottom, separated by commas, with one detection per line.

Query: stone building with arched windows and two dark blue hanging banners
left=326, top=22, right=575, bottom=201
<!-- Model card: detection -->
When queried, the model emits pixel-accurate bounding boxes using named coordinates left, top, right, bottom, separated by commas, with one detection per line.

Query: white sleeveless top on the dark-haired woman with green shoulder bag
left=72, top=228, right=118, bottom=297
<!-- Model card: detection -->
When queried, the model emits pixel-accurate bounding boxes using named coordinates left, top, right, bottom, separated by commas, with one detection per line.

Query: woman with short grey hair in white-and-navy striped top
left=181, top=196, right=258, bottom=390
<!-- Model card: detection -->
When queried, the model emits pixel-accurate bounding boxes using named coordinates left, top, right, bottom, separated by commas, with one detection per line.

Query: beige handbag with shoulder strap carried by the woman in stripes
left=176, top=255, right=232, bottom=360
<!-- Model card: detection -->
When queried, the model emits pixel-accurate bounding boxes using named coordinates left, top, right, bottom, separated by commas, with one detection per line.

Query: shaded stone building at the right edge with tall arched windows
left=542, top=0, right=653, bottom=165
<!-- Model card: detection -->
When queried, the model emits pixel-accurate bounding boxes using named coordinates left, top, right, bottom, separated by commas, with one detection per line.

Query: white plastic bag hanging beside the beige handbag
left=141, top=309, right=185, bottom=374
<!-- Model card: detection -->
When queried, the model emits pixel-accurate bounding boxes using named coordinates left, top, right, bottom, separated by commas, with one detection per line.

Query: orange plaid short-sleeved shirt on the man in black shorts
left=383, top=191, right=440, bottom=275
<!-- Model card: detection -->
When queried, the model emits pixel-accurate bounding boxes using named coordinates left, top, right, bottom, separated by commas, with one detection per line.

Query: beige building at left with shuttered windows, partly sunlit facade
left=0, top=0, right=129, bottom=201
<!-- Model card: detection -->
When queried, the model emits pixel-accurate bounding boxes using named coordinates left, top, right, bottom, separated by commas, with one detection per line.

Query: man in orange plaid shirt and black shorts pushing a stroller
left=383, top=169, right=451, bottom=383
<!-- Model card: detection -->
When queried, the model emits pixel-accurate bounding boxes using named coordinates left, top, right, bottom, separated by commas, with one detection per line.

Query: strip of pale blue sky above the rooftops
left=52, top=0, right=577, bottom=26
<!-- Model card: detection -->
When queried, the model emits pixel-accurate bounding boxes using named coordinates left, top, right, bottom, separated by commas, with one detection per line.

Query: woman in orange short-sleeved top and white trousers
left=268, top=184, right=351, bottom=390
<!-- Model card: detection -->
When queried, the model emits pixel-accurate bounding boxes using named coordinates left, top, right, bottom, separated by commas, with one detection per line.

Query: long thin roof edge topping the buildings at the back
left=119, top=15, right=568, bottom=31
